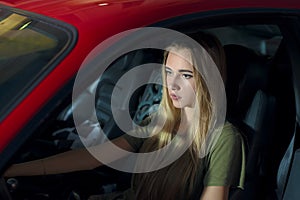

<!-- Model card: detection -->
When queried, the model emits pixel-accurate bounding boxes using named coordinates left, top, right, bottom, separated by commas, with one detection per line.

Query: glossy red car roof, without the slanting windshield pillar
left=0, top=0, right=300, bottom=50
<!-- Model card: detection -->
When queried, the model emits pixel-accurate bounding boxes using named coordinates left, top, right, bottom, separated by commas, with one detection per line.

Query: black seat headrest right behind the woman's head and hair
left=224, top=44, right=269, bottom=118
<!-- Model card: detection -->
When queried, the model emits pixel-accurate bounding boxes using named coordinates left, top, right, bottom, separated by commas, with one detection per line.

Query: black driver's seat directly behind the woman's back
left=224, top=45, right=276, bottom=200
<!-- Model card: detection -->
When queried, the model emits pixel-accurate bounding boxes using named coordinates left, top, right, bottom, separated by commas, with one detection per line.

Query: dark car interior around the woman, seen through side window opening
left=1, top=12, right=300, bottom=200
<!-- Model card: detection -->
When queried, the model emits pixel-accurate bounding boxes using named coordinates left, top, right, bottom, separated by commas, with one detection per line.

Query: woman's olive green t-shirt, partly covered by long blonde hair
left=123, top=123, right=246, bottom=199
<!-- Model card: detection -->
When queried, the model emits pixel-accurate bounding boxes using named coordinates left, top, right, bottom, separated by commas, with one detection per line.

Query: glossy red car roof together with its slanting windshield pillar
left=0, top=0, right=300, bottom=150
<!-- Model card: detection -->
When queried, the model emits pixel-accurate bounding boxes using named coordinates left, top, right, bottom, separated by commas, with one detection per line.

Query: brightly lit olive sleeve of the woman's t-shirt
left=203, top=125, right=246, bottom=188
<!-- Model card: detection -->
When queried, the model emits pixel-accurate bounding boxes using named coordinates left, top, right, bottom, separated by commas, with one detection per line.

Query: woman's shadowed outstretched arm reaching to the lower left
left=4, top=136, right=133, bottom=177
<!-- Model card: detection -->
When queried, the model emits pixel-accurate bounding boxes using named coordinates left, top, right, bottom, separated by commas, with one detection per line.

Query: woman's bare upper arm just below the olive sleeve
left=200, top=186, right=229, bottom=200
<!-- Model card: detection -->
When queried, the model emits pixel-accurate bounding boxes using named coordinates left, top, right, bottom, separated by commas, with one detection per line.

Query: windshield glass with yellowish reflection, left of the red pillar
left=0, top=8, right=73, bottom=119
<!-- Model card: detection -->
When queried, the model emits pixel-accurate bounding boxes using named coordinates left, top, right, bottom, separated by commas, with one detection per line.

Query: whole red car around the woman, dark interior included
left=0, top=0, right=300, bottom=200
